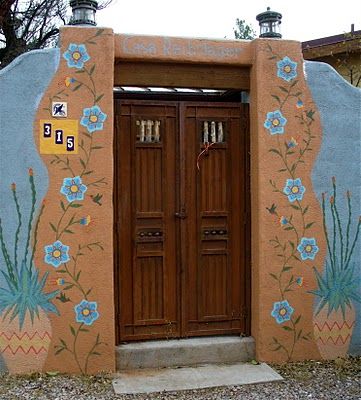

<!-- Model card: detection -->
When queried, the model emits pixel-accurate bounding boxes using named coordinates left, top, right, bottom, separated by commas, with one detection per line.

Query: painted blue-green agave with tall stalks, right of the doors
left=311, top=178, right=361, bottom=318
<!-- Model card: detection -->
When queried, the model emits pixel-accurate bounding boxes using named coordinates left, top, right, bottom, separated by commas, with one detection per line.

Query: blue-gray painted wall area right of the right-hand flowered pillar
left=305, top=62, right=361, bottom=354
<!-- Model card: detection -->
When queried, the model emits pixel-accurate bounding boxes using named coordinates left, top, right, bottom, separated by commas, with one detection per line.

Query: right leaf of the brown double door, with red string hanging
left=180, top=103, right=248, bottom=336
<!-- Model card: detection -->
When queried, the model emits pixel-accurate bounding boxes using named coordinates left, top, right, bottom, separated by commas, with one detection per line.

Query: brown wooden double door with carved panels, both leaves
left=115, top=100, right=250, bottom=342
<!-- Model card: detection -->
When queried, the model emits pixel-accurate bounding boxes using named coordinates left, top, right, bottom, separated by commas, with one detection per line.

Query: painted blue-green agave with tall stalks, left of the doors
left=0, top=169, right=59, bottom=329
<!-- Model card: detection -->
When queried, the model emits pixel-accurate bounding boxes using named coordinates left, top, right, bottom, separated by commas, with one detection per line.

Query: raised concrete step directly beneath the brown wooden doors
left=116, top=336, right=255, bottom=370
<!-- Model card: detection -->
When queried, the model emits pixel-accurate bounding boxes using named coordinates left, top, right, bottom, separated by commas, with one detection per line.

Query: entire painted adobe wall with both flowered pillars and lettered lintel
left=0, top=27, right=361, bottom=373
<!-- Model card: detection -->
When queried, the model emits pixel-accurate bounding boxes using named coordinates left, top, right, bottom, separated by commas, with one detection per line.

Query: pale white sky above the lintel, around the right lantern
left=97, top=0, right=361, bottom=41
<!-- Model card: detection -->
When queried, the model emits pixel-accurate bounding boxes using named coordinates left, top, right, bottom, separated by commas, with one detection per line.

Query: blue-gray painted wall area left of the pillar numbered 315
left=0, top=49, right=60, bottom=371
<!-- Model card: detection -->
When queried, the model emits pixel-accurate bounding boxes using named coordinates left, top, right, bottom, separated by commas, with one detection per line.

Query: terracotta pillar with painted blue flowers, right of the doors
left=251, top=40, right=324, bottom=362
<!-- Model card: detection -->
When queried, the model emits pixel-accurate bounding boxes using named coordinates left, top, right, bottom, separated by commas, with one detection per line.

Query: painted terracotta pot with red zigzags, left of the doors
left=0, top=310, right=51, bottom=374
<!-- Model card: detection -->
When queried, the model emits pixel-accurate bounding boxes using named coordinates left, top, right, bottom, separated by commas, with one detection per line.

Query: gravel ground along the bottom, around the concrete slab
left=0, top=357, right=361, bottom=400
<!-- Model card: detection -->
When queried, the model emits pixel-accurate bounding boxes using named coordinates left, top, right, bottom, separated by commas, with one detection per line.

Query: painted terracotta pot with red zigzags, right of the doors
left=313, top=307, right=356, bottom=360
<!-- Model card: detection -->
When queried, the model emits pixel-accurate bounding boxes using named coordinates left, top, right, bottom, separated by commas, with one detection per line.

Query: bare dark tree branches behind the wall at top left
left=0, top=0, right=112, bottom=68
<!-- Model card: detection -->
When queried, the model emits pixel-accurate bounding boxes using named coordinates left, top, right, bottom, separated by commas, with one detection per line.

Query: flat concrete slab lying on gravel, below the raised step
left=113, top=363, right=283, bottom=394
